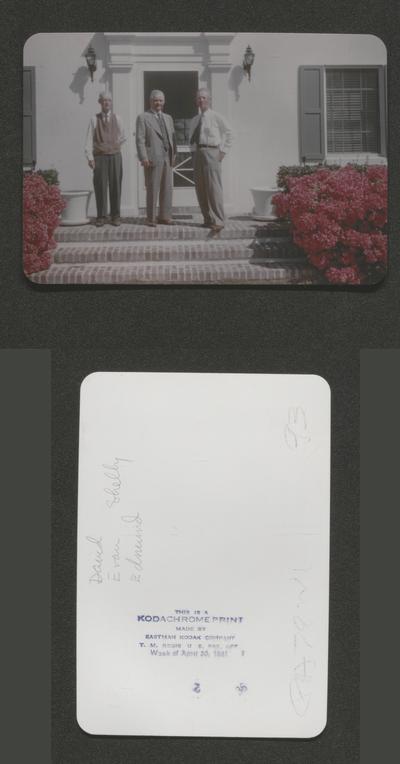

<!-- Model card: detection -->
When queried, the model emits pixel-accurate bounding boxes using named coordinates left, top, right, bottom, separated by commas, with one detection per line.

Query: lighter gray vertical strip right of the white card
left=361, top=349, right=400, bottom=764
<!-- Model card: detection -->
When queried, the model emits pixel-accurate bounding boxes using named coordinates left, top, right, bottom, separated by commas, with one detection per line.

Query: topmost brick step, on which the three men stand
left=55, top=218, right=288, bottom=243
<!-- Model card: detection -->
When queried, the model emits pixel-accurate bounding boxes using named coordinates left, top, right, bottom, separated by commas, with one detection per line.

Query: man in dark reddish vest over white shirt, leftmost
left=85, top=93, right=126, bottom=226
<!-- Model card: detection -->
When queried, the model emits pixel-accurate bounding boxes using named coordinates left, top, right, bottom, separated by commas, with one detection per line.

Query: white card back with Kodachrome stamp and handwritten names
left=77, top=372, right=330, bottom=738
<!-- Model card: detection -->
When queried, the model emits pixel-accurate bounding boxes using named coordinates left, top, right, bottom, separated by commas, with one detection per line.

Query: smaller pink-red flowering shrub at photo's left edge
left=23, top=172, right=65, bottom=275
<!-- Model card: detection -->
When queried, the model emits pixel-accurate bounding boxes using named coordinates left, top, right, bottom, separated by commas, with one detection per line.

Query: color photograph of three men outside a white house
left=23, top=32, right=387, bottom=287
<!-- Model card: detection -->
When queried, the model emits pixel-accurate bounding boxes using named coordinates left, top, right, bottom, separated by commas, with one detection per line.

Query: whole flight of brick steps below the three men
left=30, top=215, right=316, bottom=285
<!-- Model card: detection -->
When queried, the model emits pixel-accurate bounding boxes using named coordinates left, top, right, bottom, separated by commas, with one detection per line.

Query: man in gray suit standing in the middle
left=136, top=90, right=176, bottom=226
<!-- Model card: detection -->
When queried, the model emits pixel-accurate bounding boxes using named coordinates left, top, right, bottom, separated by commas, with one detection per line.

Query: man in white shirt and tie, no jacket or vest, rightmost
left=189, top=88, right=233, bottom=233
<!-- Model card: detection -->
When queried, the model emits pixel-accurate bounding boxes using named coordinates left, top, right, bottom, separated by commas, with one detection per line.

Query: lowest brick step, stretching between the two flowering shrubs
left=30, top=260, right=316, bottom=286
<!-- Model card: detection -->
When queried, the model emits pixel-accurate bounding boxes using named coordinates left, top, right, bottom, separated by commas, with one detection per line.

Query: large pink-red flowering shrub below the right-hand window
left=273, top=165, right=387, bottom=284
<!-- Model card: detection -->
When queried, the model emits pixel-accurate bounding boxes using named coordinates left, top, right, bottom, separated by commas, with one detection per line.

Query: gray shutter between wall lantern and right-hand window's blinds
left=299, top=66, right=325, bottom=161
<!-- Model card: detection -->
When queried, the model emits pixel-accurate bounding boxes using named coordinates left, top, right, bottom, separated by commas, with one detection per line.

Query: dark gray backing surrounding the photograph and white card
left=0, top=0, right=400, bottom=764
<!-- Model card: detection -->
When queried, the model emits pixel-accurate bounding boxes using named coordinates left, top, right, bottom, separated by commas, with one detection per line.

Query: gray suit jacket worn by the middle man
left=136, top=111, right=176, bottom=164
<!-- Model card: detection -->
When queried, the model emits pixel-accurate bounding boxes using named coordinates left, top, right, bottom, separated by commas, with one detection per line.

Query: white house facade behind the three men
left=24, top=32, right=387, bottom=216
